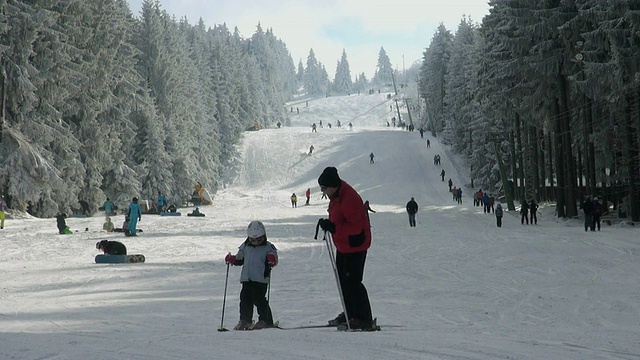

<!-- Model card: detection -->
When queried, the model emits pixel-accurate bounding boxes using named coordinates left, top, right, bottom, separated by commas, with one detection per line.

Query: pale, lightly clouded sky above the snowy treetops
left=129, top=0, right=489, bottom=79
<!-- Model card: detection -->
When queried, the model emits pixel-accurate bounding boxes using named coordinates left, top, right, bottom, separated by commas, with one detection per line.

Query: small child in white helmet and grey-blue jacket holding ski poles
left=224, top=221, right=278, bottom=330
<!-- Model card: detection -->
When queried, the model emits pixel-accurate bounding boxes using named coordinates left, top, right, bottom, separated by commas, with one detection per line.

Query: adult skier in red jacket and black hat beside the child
left=318, top=167, right=373, bottom=329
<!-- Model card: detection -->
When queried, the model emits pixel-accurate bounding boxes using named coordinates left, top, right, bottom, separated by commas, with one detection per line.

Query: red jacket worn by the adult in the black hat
left=328, top=181, right=371, bottom=254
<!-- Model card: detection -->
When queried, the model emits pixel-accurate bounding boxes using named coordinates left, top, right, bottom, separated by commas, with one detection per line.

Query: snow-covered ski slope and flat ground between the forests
left=0, top=93, right=640, bottom=360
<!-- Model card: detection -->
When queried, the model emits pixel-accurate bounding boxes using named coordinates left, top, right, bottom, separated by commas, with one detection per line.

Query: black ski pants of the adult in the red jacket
left=336, top=250, right=373, bottom=322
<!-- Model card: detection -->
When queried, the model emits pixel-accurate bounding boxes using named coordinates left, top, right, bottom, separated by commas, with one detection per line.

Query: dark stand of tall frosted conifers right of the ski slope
left=418, top=0, right=640, bottom=221
